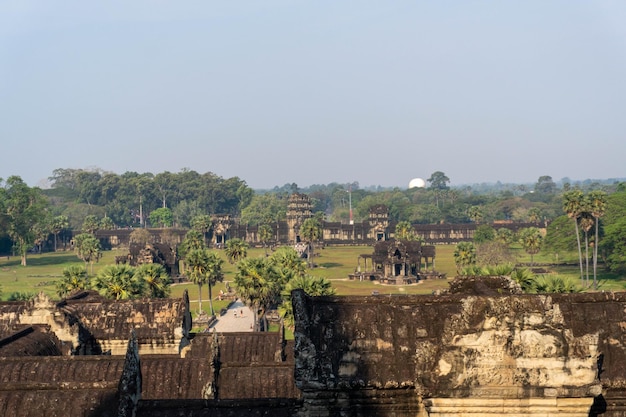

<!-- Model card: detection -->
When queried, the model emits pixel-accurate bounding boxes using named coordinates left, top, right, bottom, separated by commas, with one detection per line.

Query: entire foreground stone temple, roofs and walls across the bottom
left=0, top=280, right=626, bottom=417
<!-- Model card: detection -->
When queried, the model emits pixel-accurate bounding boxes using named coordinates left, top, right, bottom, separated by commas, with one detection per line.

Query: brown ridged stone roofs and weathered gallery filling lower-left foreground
left=0, top=293, right=300, bottom=417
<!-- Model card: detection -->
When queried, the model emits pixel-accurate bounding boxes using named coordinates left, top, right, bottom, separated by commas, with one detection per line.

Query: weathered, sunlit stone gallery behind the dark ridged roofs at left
left=0, top=292, right=188, bottom=355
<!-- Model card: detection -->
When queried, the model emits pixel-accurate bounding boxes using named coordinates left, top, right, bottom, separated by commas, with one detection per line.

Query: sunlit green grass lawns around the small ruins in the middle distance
left=0, top=245, right=626, bottom=304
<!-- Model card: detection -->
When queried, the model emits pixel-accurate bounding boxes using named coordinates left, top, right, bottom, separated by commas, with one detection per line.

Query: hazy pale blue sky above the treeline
left=0, top=0, right=626, bottom=189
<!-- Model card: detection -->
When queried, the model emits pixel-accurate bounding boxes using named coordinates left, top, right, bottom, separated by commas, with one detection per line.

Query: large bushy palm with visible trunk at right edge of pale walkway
left=234, top=258, right=282, bottom=331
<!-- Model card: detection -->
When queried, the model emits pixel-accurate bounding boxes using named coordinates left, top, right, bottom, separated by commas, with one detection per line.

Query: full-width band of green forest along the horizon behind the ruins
left=0, top=169, right=626, bottom=271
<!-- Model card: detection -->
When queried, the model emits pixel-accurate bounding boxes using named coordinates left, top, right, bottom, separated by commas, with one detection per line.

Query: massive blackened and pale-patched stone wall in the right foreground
left=293, top=291, right=626, bottom=417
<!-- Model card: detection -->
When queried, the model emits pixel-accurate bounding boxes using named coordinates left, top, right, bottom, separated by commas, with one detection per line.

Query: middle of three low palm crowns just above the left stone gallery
left=92, top=265, right=143, bottom=300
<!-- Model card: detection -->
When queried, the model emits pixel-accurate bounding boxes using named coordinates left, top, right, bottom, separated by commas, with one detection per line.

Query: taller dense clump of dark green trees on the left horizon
left=46, top=169, right=254, bottom=228
